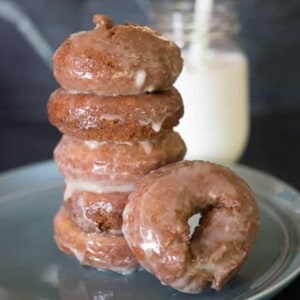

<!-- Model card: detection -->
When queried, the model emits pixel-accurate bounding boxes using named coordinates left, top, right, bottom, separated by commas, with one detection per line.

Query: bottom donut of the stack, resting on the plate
left=54, top=207, right=138, bottom=274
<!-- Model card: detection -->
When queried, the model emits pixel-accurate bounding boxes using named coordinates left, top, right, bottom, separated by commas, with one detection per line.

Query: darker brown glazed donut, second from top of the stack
left=48, top=88, right=183, bottom=141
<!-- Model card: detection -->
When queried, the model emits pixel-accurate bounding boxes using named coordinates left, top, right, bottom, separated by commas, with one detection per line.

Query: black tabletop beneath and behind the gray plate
left=0, top=112, right=300, bottom=300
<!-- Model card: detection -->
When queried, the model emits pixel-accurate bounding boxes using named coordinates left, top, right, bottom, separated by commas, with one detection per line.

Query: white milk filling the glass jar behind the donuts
left=175, top=50, right=249, bottom=163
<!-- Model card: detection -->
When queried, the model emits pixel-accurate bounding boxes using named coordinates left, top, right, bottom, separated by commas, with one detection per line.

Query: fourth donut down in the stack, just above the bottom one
left=64, top=191, right=128, bottom=235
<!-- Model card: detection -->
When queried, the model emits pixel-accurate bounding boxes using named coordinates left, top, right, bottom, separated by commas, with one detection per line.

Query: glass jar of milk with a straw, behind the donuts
left=148, top=0, right=249, bottom=164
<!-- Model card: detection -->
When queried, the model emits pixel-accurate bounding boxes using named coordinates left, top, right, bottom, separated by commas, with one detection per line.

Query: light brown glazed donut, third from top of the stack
left=54, top=131, right=186, bottom=183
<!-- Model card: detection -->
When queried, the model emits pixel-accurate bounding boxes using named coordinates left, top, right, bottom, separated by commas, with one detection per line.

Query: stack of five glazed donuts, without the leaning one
left=48, top=15, right=186, bottom=273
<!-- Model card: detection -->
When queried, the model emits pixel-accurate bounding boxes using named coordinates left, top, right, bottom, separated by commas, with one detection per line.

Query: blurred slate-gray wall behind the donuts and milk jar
left=0, top=0, right=300, bottom=121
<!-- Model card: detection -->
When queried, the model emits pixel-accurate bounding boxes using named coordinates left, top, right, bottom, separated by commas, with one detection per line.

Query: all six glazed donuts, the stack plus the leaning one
left=48, top=15, right=259, bottom=293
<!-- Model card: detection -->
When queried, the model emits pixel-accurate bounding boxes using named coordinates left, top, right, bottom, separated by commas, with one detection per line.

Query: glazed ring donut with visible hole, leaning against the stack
left=122, top=161, right=259, bottom=293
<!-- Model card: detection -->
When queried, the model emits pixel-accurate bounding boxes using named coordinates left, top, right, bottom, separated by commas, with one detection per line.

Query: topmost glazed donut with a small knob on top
left=53, top=15, right=183, bottom=96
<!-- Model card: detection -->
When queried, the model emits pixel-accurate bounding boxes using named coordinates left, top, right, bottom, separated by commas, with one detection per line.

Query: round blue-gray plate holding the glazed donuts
left=0, top=162, right=300, bottom=300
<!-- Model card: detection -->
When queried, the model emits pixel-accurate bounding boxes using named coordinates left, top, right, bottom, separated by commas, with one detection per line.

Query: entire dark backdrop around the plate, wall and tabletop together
left=0, top=0, right=300, bottom=300
